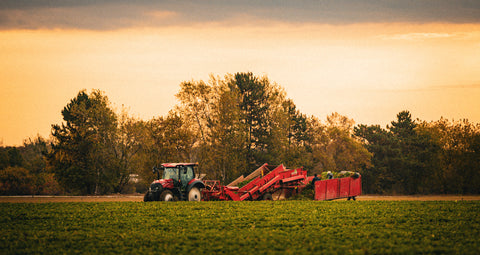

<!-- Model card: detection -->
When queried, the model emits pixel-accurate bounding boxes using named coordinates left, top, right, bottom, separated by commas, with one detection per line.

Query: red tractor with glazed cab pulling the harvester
left=143, top=163, right=205, bottom=202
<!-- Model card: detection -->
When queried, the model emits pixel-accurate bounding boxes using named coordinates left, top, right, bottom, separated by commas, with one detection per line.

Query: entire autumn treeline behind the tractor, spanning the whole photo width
left=0, top=73, right=480, bottom=195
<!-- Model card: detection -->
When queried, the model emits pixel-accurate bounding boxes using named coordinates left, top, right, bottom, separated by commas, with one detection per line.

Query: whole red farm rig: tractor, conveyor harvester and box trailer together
left=144, top=163, right=361, bottom=202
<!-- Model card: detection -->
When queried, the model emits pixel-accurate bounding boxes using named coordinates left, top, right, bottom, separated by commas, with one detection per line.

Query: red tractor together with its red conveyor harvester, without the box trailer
left=144, top=163, right=311, bottom=202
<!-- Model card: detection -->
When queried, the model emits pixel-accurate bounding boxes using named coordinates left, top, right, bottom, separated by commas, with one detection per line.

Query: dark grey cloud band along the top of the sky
left=0, top=0, right=480, bottom=30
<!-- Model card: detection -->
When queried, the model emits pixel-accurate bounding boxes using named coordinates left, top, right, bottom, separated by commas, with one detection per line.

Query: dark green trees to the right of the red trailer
left=354, top=111, right=480, bottom=194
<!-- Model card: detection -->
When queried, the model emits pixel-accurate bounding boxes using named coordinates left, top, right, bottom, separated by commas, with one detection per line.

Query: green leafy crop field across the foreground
left=0, top=201, right=480, bottom=254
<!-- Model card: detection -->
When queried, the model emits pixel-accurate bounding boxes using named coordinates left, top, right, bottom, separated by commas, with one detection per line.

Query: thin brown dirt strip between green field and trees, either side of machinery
left=0, top=194, right=480, bottom=203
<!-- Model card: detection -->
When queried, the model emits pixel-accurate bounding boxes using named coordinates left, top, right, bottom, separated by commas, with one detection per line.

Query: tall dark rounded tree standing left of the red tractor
left=51, top=90, right=119, bottom=194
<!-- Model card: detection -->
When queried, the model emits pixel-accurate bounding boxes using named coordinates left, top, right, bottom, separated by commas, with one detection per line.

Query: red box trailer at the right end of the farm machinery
left=315, top=176, right=362, bottom=200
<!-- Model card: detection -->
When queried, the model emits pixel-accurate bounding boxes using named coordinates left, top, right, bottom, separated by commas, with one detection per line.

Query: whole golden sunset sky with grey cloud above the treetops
left=0, top=0, right=480, bottom=146
